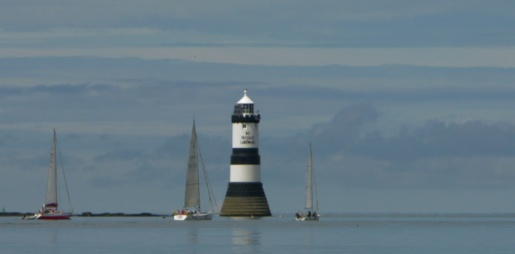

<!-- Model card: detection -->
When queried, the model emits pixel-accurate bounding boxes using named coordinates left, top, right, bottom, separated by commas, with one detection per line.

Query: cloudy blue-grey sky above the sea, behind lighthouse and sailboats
left=0, top=0, right=515, bottom=215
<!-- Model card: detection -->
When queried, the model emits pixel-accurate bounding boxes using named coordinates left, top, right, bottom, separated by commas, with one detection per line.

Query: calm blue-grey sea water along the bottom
left=0, top=214, right=515, bottom=254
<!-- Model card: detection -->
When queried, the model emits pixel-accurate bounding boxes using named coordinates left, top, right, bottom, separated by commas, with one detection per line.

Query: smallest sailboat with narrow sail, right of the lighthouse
left=295, top=144, right=320, bottom=221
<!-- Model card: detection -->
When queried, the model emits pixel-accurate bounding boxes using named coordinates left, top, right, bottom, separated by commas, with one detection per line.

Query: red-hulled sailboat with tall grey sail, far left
left=23, top=129, right=72, bottom=220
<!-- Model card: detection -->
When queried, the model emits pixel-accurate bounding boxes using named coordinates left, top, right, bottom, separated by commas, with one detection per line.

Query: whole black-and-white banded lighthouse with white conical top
left=220, top=89, right=272, bottom=217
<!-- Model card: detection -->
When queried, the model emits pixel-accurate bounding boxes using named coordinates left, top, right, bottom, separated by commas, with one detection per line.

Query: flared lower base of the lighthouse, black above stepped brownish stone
left=220, top=182, right=272, bottom=217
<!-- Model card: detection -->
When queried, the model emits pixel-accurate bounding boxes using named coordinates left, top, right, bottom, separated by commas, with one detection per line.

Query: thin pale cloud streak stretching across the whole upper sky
left=0, top=47, right=515, bottom=68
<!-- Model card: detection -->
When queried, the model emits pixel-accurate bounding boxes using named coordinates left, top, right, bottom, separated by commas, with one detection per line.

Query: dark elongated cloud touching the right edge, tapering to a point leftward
left=347, top=120, right=515, bottom=162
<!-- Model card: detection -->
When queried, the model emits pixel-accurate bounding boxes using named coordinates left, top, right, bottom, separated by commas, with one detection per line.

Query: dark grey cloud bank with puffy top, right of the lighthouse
left=260, top=104, right=515, bottom=189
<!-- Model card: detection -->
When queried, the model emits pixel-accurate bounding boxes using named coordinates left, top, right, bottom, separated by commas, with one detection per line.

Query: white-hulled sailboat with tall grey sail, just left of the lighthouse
left=173, top=122, right=216, bottom=221
